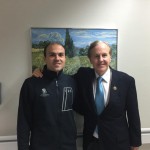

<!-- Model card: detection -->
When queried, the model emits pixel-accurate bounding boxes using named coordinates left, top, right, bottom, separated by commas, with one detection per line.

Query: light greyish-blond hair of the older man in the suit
left=88, top=41, right=112, bottom=58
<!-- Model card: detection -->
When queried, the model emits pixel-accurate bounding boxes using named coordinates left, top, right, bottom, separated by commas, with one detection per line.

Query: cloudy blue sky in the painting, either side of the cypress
left=31, top=28, right=118, bottom=48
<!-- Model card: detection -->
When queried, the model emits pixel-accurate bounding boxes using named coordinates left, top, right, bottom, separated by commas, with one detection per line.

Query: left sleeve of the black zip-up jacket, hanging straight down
left=17, top=80, right=32, bottom=150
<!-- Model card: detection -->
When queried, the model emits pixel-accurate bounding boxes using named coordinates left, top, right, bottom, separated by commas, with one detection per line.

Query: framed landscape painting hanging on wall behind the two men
left=31, top=28, right=118, bottom=75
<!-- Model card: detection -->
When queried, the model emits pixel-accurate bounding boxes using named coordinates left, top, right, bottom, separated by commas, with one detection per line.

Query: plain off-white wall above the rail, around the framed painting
left=0, top=0, right=150, bottom=136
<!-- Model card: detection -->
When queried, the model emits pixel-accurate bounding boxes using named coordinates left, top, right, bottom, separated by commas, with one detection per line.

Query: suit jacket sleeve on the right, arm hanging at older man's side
left=127, top=78, right=141, bottom=147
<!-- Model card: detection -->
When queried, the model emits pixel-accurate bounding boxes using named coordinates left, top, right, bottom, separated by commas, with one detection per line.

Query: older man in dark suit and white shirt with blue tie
left=74, top=41, right=141, bottom=150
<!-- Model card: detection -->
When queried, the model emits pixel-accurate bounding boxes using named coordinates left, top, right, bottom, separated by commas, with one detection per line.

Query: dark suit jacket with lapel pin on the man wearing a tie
left=74, top=68, right=141, bottom=150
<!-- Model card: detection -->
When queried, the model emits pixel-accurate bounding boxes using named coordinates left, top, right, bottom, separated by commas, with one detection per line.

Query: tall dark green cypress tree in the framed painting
left=65, top=29, right=75, bottom=58
